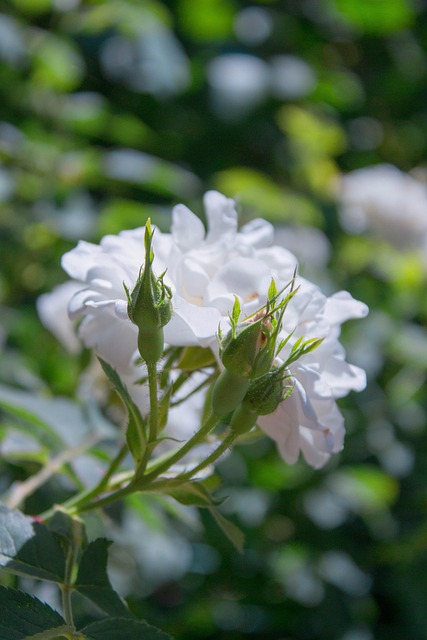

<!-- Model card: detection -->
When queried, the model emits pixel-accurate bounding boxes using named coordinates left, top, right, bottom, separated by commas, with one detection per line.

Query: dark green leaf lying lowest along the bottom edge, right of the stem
left=80, top=618, right=173, bottom=640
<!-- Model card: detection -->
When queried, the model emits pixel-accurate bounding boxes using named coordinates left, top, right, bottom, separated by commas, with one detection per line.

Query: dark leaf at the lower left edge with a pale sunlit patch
left=0, top=505, right=65, bottom=582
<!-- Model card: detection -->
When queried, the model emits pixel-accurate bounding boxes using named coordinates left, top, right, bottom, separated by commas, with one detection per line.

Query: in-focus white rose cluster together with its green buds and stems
left=36, top=191, right=367, bottom=511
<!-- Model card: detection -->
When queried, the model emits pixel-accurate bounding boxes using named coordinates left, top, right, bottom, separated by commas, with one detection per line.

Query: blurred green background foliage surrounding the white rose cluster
left=0, top=0, right=427, bottom=640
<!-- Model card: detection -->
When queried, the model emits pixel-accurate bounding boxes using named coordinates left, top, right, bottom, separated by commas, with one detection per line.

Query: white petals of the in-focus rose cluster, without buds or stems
left=38, top=191, right=367, bottom=467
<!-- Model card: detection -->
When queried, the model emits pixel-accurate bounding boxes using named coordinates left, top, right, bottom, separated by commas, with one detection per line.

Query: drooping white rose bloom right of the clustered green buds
left=258, top=288, right=367, bottom=468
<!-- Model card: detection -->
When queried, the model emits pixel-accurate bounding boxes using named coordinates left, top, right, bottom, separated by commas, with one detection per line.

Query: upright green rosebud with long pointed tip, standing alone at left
left=125, top=220, right=172, bottom=364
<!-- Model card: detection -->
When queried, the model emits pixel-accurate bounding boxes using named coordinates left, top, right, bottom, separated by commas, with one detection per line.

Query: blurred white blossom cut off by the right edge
left=337, top=164, right=427, bottom=249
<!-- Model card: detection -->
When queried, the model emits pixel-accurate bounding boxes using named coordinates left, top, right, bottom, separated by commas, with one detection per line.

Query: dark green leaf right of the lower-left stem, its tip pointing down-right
left=74, top=538, right=131, bottom=617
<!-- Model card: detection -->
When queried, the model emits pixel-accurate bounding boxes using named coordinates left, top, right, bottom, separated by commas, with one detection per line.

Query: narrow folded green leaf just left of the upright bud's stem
left=98, top=358, right=147, bottom=465
